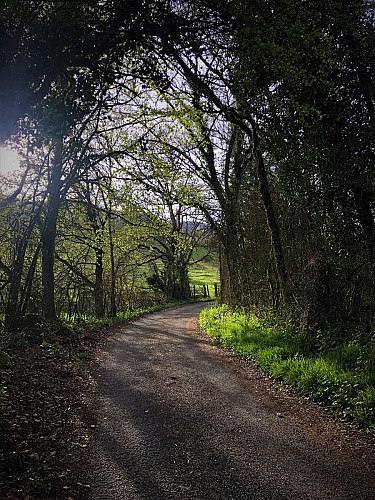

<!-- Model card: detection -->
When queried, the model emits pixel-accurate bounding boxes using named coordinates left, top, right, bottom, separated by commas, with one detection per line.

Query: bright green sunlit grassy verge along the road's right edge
left=200, top=306, right=375, bottom=432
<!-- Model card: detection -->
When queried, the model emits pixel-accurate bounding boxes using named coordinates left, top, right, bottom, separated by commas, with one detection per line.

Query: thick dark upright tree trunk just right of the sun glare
left=41, top=141, right=63, bottom=322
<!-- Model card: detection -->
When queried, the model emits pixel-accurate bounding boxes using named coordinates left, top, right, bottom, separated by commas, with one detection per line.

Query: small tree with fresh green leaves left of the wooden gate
left=114, top=129, right=212, bottom=300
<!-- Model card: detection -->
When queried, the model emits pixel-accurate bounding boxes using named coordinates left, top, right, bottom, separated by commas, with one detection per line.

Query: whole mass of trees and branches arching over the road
left=0, top=0, right=375, bottom=335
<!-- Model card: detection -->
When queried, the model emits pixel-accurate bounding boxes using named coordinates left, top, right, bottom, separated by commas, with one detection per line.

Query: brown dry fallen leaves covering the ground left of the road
left=0, top=332, right=100, bottom=500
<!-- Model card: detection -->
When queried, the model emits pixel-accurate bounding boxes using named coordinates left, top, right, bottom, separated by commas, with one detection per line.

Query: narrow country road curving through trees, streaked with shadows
left=89, top=304, right=375, bottom=500
